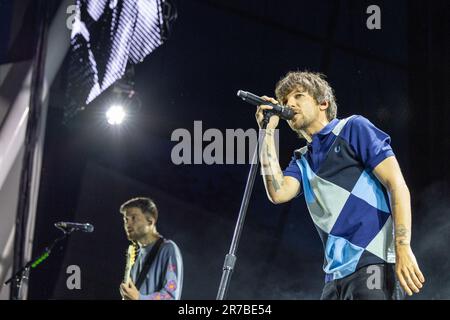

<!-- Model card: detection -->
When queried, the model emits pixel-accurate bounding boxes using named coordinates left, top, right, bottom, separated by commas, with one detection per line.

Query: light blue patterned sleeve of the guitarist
left=139, top=243, right=183, bottom=300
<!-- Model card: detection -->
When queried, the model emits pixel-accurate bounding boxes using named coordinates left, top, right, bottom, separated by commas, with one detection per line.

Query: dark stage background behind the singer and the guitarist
left=20, top=0, right=450, bottom=299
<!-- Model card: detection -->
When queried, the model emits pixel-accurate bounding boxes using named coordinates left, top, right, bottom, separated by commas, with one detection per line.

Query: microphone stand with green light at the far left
left=5, top=228, right=75, bottom=300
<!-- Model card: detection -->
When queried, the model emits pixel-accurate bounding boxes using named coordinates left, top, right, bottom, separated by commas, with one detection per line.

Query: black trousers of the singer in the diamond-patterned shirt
left=320, top=264, right=405, bottom=300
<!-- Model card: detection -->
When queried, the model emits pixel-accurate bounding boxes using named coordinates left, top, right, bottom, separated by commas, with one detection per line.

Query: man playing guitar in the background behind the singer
left=120, top=197, right=183, bottom=300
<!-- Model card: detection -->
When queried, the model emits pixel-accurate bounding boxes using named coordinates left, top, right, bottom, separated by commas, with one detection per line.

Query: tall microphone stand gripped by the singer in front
left=216, top=110, right=273, bottom=300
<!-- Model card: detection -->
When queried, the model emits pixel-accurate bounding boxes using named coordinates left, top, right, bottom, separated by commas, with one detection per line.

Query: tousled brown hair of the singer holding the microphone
left=275, top=71, right=337, bottom=121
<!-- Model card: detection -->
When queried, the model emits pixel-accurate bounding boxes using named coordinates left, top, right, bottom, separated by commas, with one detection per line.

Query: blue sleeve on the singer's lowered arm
left=349, top=116, right=394, bottom=170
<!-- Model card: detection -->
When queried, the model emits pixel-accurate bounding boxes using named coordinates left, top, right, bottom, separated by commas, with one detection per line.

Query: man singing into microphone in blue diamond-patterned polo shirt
left=256, top=72, right=425, bottom=300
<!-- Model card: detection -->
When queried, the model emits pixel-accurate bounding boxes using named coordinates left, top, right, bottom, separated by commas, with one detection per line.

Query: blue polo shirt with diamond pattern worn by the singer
left=284, top=115, right=395, bottom=282
